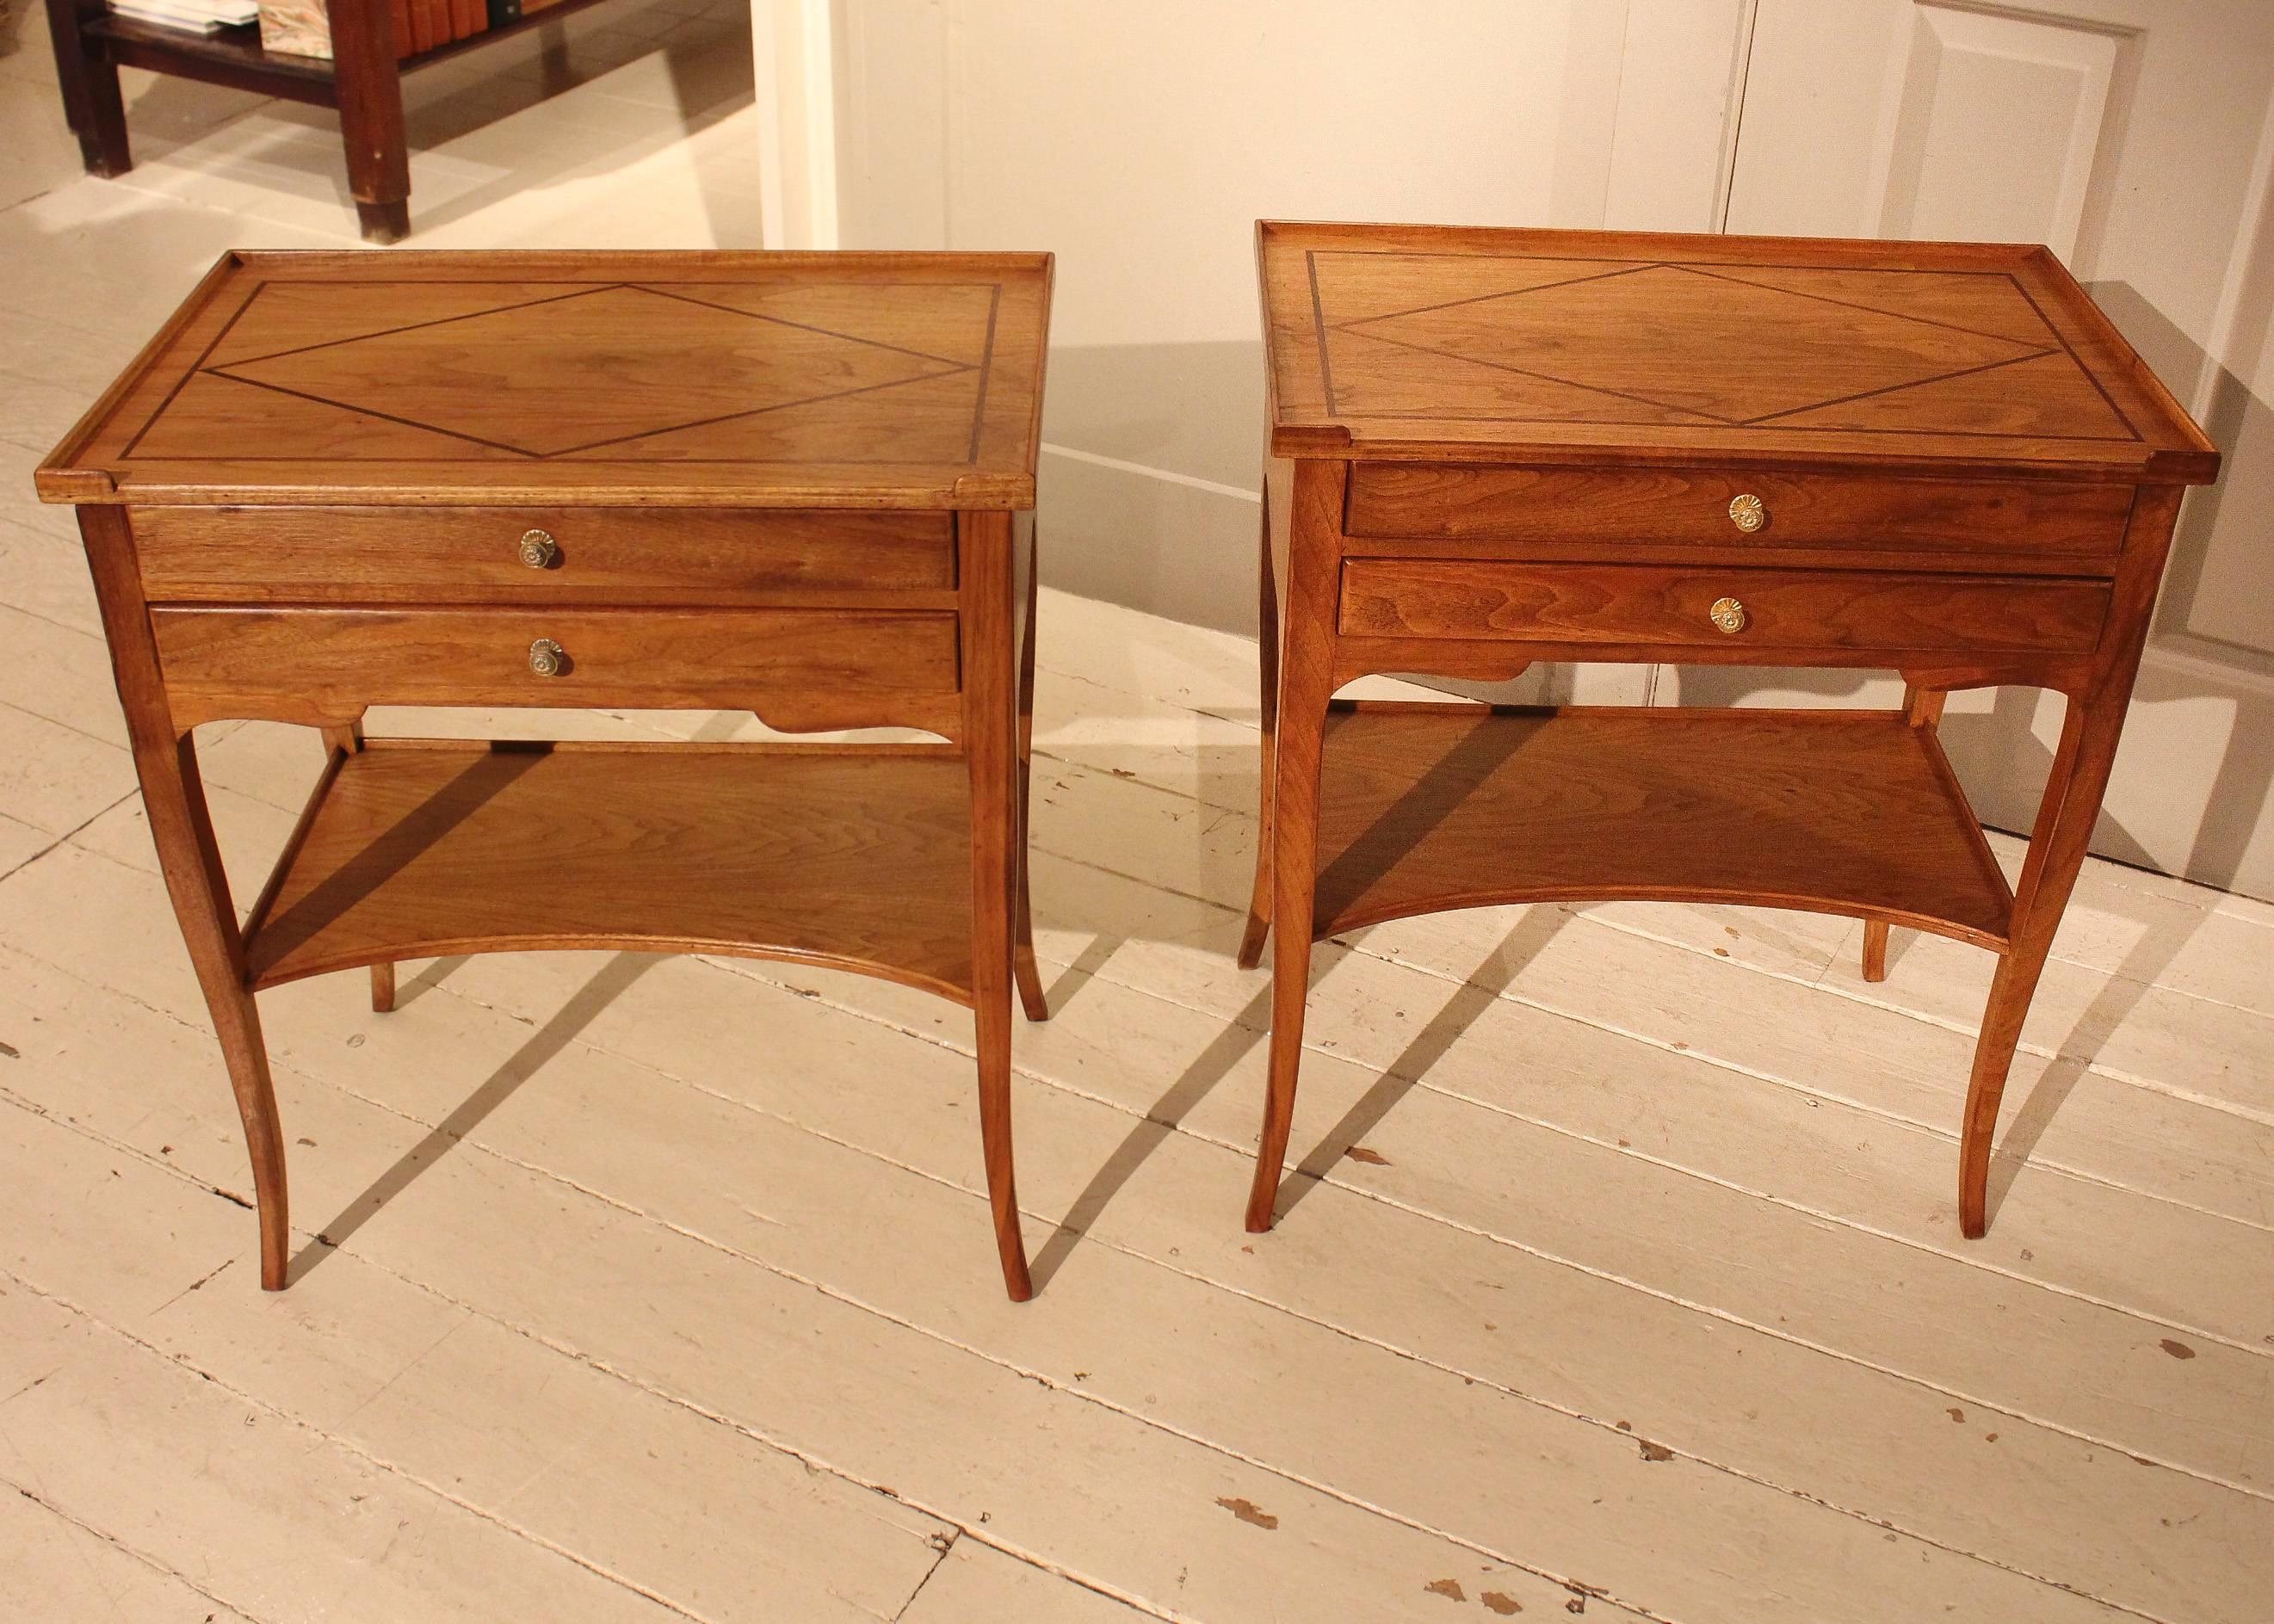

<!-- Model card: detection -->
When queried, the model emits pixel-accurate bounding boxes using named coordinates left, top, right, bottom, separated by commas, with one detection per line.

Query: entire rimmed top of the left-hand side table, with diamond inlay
left=39, top=250, right=1051, bottom=509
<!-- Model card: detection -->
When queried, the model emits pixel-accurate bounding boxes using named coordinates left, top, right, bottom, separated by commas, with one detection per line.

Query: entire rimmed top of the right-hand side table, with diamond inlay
left=1257, top=220, right=2217, bottom=482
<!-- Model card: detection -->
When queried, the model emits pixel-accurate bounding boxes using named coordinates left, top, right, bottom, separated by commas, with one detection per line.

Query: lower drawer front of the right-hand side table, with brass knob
left=1342, top=558, right=2108, bottom=653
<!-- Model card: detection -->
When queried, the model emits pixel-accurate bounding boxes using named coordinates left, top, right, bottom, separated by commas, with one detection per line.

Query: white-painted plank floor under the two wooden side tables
left=0, top=9, right=2274, bottom=1624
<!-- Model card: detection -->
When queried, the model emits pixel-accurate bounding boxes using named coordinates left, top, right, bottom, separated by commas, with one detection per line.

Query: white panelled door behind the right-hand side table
left=1709, top=0, right=2274, bottom=896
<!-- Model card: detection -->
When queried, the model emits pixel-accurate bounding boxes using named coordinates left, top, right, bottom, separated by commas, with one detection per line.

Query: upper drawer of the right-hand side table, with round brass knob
left=1349, top=462, right=2133, bottom=569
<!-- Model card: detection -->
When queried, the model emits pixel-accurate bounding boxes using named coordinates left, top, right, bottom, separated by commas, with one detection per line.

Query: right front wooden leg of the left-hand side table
left=957, top=514, right=1035, bottom=1303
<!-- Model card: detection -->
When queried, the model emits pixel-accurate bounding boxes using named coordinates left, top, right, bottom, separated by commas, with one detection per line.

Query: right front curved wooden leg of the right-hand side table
left=1958, top=487, right=2183, bottom=1239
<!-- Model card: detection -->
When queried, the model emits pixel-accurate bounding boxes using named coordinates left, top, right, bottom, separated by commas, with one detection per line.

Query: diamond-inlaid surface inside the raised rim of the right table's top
left=1312, top=250, right=2135, bottom=439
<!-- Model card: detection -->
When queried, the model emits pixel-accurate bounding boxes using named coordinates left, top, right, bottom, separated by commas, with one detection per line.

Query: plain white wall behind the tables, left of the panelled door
left=835, top=0, right=1739, bottom=630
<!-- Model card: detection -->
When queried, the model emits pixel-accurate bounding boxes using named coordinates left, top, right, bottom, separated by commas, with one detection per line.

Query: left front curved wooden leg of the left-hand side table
left=79, top=505, right=291, bottom=1292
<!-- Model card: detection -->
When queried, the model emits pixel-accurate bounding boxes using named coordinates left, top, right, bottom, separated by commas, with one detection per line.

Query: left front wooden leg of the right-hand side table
left=1248, top=462, right=1346, bottom=1235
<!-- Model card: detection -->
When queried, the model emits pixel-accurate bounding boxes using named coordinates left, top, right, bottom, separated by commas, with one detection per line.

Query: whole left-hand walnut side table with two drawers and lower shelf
left=39, top=252, right=1051, bottom=1299
